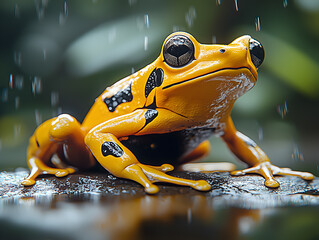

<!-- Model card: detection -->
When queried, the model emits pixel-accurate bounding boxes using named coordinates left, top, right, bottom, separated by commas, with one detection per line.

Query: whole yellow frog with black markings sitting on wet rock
left=22, top=32, right=314, bottom=194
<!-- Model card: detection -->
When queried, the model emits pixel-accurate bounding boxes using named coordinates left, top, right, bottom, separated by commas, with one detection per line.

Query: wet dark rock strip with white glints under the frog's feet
left=0, top=170, right=319, bottom=208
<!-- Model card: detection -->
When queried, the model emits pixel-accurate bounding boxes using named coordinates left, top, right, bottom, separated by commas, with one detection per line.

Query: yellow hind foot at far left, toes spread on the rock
left=21, top=157, right=75, bottom=186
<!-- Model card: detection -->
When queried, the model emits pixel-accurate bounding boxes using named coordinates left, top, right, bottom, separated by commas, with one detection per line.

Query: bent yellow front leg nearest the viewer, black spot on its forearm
left=85, top=109, right=211, bottom=194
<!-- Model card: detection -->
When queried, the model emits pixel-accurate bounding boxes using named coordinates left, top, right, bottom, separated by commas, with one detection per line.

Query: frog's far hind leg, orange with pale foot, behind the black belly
left=178, top=140, right=236, bottom=172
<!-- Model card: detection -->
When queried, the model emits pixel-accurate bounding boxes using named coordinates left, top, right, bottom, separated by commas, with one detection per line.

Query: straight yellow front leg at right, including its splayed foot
left=222, top=117, right=314, bottom=188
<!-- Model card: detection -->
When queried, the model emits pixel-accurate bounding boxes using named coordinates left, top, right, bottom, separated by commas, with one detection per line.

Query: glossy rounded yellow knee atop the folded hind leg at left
left=49, top=114, right=80, bottom=141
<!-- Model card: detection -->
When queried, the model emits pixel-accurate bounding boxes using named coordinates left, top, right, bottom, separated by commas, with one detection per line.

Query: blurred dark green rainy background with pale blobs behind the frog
left=0, top=0, right=319, bottom=175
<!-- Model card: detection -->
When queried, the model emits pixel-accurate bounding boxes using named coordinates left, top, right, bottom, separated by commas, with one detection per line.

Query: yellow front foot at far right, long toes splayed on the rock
left=230, top=162, right=314, bottom=188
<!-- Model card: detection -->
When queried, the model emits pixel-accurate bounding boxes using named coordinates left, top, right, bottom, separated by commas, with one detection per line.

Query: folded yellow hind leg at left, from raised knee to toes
left=22, top=114, right=93, bottom=186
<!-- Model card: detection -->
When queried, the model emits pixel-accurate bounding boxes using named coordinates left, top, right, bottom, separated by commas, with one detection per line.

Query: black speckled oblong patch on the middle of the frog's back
left=104, top=84, right=133, bottom=112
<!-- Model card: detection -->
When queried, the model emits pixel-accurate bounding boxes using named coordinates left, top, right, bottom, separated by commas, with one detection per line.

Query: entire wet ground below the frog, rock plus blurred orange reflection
left=0, top=170, right=319, bottom=240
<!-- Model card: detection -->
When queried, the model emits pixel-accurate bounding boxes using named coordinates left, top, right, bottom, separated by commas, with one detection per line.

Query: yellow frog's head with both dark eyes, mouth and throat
left=154, top=32, right=264, bottom=123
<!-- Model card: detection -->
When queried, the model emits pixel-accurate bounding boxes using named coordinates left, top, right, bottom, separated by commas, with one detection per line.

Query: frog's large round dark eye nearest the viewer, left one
left=163, top=35, right=194, bottom=67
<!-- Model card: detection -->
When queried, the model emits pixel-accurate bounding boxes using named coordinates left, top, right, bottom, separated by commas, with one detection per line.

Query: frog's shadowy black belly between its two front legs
left=122, top=128, right=215, bottom=165
